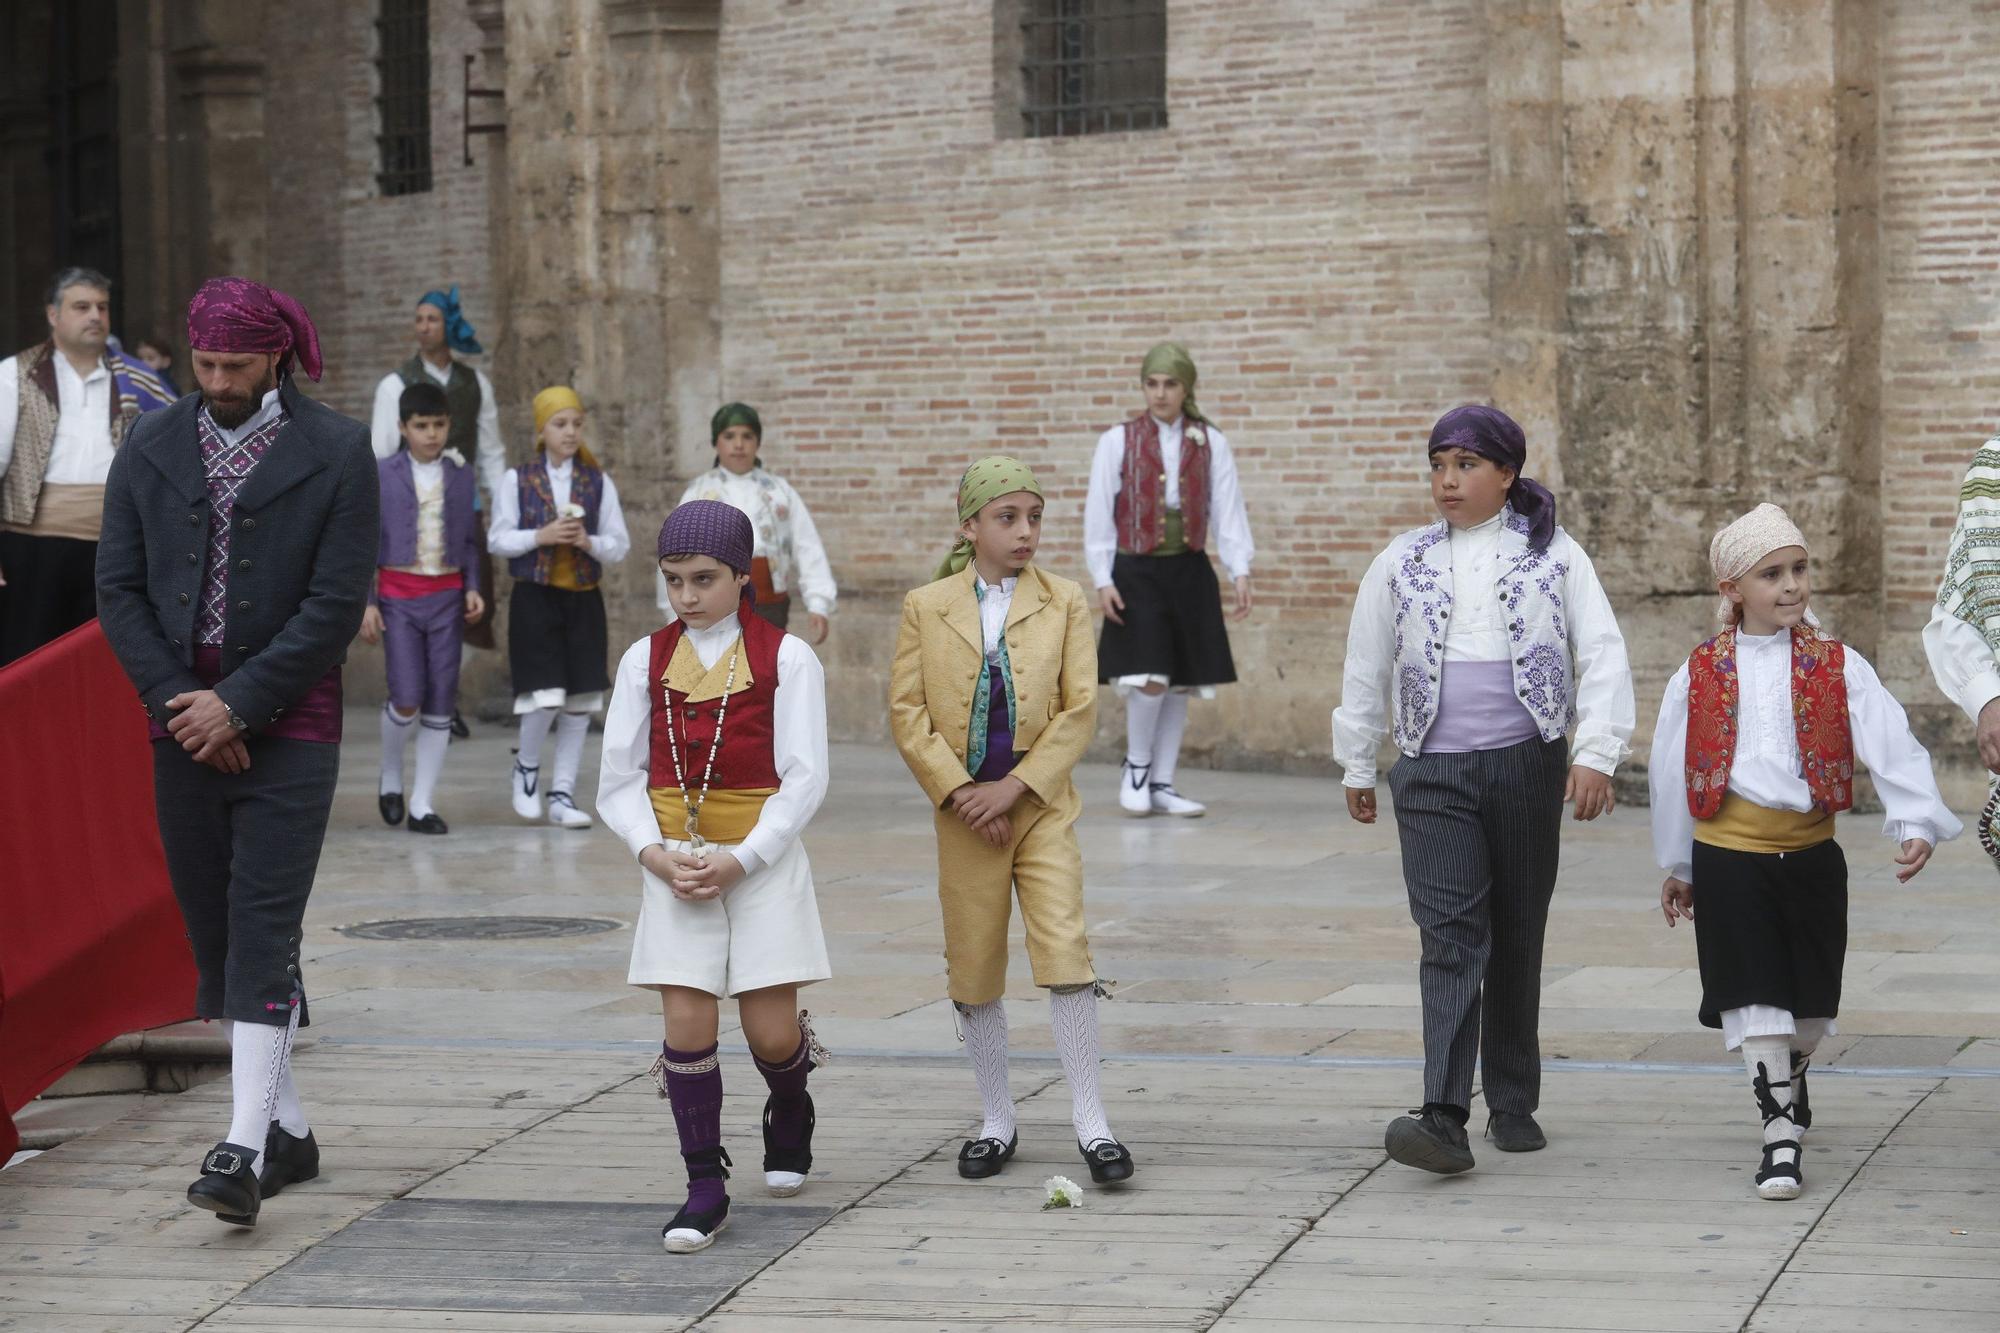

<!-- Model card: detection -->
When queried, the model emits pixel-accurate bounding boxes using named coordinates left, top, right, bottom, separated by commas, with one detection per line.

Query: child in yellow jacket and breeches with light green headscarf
left=890, top=456, right=1132, bottom=1183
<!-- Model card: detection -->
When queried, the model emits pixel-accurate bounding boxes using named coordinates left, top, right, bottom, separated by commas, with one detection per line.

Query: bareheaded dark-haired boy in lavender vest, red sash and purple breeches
left=362, top=382, right=486, bottom=833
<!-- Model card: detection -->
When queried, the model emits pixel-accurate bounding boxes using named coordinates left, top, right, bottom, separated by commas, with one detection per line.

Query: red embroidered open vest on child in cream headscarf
left=1686, top=626, right=1854, bottom=819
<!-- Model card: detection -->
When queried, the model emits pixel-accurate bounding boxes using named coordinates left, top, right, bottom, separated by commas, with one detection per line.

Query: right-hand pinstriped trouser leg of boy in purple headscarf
left=1480, top=741, right=1570, bottom=1115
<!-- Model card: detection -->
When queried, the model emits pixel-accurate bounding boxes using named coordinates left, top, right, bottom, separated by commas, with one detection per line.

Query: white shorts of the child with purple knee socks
left=626, top=843, right=832, bottom=995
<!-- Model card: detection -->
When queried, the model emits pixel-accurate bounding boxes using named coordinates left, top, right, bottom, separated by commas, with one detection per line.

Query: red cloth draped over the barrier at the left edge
left=0, top=620, right=194, bottom=1161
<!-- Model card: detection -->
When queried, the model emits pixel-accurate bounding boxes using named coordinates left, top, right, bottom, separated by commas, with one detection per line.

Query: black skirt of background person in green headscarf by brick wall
left=1098, top=550, right=1236, bottom=685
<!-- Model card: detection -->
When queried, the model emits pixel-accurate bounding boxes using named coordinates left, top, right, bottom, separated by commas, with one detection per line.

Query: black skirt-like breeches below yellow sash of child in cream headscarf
left=1694, top=839, right=1848, bottom=1027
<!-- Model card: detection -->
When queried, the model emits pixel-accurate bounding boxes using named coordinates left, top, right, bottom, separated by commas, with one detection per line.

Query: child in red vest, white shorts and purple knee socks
left=598, top=500, right=830, bottom=1255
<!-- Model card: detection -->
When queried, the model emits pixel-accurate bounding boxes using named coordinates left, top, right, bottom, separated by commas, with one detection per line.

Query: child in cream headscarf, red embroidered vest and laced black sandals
left=1650, top=504, right=1960, bottom=1199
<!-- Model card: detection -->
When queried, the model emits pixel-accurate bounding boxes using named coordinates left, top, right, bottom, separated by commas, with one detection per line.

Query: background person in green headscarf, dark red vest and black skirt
left=1084, top=342, right=1256, bottom=819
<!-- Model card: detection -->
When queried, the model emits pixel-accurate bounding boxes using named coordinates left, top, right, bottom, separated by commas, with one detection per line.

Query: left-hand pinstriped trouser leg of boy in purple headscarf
left=1388, top=753, right=1492, bottom=1109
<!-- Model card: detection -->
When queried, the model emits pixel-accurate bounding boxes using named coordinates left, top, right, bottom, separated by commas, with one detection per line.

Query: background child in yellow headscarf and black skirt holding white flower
left=486, top=384, right=632, bottom=829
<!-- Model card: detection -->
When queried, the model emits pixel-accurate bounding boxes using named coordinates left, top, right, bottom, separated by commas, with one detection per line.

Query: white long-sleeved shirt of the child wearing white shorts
left=598, top=612, right=828, bottom=875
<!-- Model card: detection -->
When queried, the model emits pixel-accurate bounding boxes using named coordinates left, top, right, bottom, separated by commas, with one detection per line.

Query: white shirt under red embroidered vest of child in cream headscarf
left=1648, top=632, right=1962, bottom=885
